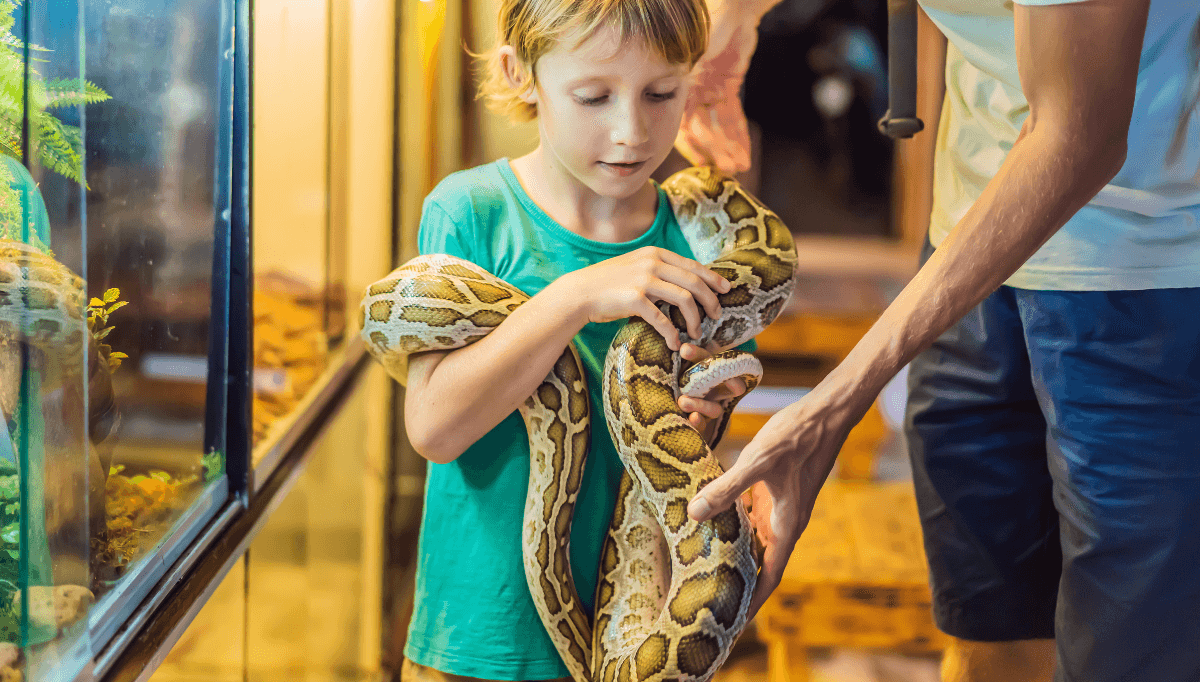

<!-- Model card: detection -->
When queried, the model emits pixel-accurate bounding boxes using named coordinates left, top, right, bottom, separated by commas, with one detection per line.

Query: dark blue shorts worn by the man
left=906, top=242, right=1200, bottom=682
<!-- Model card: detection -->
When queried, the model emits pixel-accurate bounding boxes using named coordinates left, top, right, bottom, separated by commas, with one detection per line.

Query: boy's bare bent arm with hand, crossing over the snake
left=404, top=246, right=730, bottom=463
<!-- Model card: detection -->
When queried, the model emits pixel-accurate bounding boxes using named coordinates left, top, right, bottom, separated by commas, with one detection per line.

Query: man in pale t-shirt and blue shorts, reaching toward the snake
left=678, top=0, right=1200, bottom=682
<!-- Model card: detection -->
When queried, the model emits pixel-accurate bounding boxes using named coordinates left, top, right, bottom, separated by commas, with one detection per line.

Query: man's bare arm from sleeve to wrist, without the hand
left=835, top=0, right=1148, bottom=409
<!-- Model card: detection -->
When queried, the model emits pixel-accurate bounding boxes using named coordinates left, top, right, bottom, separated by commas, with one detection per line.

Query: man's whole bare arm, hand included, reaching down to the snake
left=689, top=0, right=1148, bottom=609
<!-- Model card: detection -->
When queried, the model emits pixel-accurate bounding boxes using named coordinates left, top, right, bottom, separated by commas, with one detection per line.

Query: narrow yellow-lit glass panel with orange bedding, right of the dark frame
left=251, top=0, right=333, bottom=466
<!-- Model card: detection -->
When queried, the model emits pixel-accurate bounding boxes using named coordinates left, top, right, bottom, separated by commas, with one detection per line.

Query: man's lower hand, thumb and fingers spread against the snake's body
left=688, top=383, right=874, bottom=617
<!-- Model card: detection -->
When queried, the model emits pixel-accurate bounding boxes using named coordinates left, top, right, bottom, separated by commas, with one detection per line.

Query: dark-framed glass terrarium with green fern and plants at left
left=0, top=0, right=232, bottom=680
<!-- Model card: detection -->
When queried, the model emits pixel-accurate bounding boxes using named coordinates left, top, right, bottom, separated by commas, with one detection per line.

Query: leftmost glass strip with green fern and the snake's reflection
left=0, top=0, right=93, bottom=680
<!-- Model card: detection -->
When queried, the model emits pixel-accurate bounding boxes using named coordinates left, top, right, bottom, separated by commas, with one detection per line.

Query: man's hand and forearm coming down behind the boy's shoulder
left=676, top=0, right=778, bottom=174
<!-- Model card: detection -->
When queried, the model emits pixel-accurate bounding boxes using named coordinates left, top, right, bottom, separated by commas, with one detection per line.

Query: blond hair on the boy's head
left=472, top=0, right=709, bottom=122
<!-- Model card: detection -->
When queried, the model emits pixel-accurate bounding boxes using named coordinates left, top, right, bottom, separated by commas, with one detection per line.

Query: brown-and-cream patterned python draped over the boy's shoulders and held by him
left=361, top=166, right=797, bottom=682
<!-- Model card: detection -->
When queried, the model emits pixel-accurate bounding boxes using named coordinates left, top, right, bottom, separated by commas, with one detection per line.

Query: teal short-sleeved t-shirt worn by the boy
left=404, top=158, right=754, bottom=680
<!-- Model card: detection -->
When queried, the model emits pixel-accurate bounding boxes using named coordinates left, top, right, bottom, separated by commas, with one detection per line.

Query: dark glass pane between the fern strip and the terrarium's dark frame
left=84, top=0, right=228, bottom=596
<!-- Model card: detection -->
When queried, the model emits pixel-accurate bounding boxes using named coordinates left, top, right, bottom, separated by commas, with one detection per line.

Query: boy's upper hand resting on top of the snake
left=556, top=246, right=730, bottom=351
